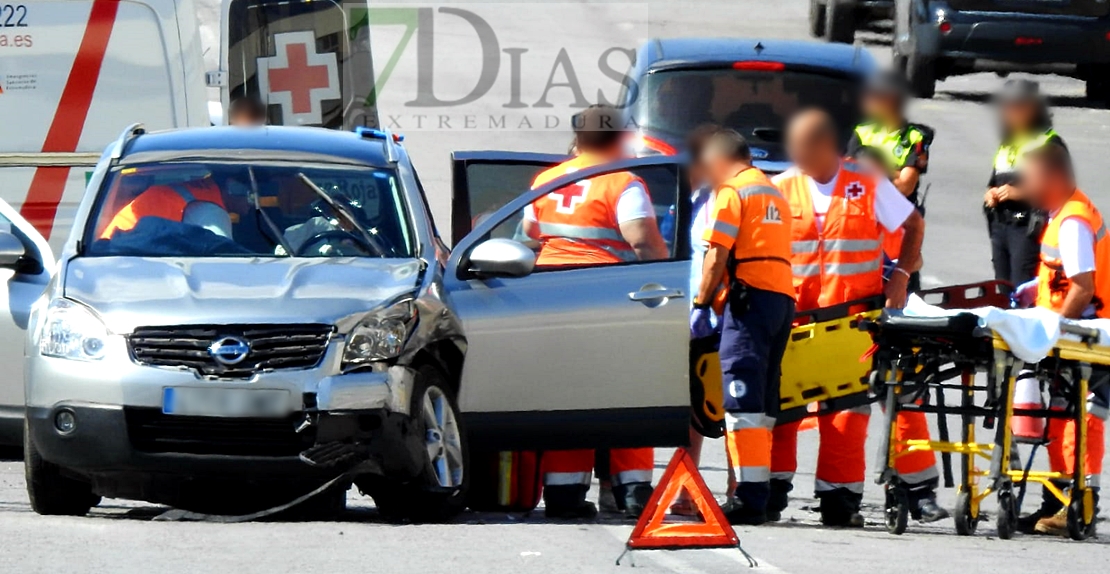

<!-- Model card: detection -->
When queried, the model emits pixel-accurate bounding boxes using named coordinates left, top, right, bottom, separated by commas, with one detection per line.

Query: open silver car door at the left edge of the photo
left=0, top=200, right=56, bottom=446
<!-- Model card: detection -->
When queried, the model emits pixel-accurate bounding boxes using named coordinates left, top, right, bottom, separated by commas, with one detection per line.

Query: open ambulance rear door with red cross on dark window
left=216, top=0, right=379, bottom=130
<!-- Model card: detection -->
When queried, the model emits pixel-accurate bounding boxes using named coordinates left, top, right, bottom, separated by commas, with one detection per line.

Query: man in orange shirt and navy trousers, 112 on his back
left=690, top=130, right=794, bottom=525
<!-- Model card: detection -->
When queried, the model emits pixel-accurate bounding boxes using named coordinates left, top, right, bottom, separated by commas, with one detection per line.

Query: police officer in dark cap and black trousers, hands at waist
left=983, top=80, right=1063, bottom=285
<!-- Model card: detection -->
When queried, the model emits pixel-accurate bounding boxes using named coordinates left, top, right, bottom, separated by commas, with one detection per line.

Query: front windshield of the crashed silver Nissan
left=84, top=162, right=413, bottom=258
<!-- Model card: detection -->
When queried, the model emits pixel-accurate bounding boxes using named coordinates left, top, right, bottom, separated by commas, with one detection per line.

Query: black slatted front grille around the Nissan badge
left=128, top=324, right=332, bottom=377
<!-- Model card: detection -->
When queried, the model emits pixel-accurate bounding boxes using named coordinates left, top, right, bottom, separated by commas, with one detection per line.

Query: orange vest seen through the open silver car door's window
left=532, top=153, right=647, bottom=265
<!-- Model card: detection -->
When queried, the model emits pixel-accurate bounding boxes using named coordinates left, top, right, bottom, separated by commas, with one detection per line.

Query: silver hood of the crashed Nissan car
left=63, top=256, right=423, bottom=333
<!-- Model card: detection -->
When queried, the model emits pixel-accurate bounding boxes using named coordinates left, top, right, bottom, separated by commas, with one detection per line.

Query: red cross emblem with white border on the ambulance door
left=258, top=31, right=340, bottom=125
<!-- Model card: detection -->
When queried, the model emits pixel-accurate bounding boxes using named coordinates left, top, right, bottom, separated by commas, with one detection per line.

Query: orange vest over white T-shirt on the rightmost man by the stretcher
left=1037, top=190, right=1110, bottom=319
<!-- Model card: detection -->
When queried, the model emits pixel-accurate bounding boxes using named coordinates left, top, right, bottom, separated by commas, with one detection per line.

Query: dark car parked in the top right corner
left=892, top=0, right=1110, bottom=99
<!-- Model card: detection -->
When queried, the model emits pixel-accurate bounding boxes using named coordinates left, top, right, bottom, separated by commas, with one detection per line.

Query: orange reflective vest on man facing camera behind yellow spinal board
left=774, top=161, right=884, bottom=311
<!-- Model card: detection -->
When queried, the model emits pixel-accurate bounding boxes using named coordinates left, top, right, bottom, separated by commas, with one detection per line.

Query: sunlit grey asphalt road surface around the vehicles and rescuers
left=0, top=0, right=1110, bottom=574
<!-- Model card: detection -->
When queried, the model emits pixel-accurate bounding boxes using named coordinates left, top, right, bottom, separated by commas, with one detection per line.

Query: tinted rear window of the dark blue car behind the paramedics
left=635, top=68, right=859, bottom=152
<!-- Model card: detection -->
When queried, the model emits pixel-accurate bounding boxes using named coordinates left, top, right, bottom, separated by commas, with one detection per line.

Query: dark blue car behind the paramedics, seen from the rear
left=620, top=38, right=875, bottom=167
